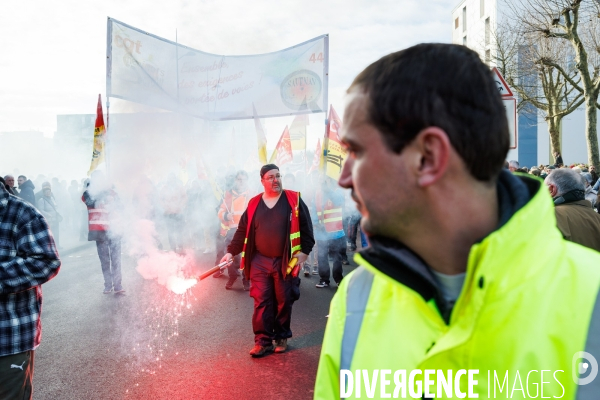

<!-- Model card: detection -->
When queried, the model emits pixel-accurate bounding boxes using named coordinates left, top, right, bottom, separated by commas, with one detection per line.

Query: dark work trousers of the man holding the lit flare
left=250, top=252, right=294, bottom=346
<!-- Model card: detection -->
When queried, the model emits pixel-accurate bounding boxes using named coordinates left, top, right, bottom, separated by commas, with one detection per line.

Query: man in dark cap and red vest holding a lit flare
left=221, top=164, right=315, bottom=357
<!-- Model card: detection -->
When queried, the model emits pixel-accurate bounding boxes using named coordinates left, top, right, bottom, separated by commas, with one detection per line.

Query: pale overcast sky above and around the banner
left=0, top=0, right=458, bottom=136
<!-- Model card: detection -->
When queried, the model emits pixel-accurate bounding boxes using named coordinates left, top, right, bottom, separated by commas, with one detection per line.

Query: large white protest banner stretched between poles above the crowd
left=106, top=18, right=329, bottom=120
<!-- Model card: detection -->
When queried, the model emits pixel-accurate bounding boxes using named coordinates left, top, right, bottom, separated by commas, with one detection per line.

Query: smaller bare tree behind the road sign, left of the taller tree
left=494, top=26, right=584, bottom=161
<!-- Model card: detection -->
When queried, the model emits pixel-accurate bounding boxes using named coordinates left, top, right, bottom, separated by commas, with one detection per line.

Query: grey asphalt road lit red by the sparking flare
left=34, top=242, right=353, bottom=400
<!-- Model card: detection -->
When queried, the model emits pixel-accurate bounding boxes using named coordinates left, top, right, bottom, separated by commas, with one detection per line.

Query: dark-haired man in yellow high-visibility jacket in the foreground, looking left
left=315, top=44, right=600, bottom=399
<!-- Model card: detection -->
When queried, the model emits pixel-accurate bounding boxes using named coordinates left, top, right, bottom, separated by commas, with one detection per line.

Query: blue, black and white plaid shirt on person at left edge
left=0, top=184, right=60, bottom=356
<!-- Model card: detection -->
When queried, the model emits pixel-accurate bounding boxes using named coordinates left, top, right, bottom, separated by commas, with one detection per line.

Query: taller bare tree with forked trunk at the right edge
left=509, top=0, right=600, bottom=168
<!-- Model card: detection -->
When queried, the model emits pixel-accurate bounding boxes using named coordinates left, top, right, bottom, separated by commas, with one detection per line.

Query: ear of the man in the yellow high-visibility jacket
left=413, top=126, right=452, bottom=187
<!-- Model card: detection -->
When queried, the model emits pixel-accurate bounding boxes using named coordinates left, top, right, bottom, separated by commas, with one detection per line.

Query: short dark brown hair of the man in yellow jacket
left=348, top=43, right=509, bottom=181
